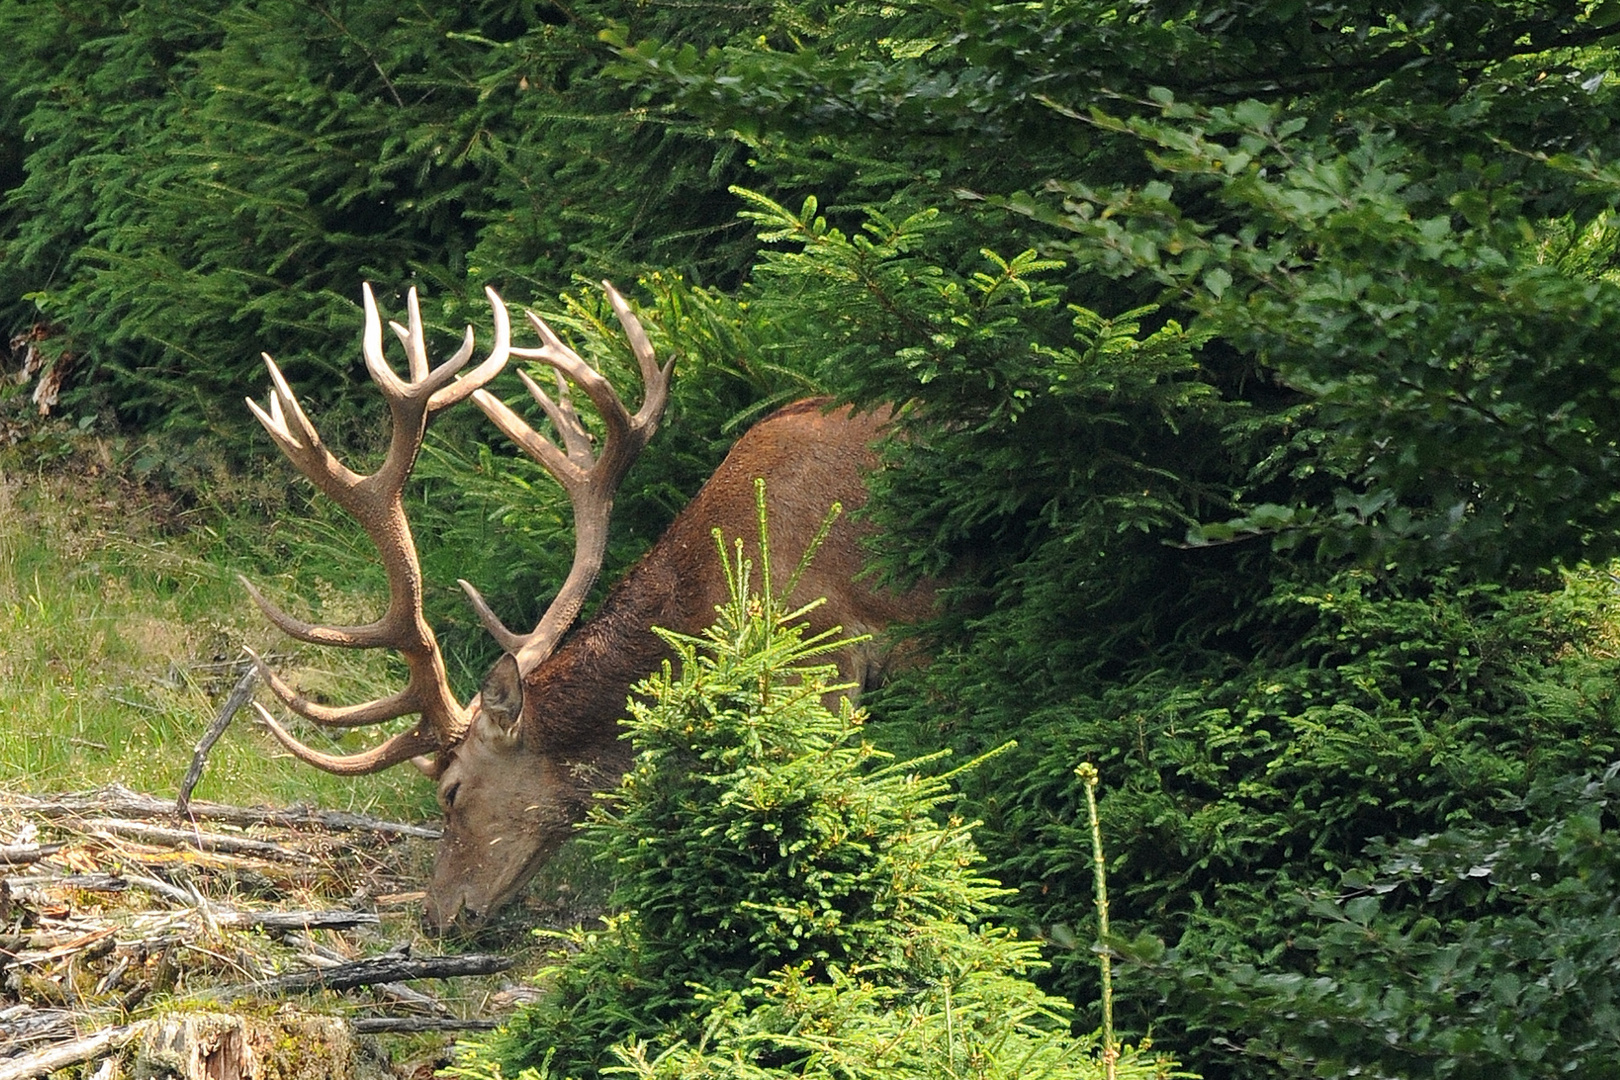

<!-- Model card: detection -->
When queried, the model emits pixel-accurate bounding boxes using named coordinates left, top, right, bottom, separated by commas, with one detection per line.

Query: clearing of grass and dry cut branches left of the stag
left=0, top=437, right=615, bottom=1077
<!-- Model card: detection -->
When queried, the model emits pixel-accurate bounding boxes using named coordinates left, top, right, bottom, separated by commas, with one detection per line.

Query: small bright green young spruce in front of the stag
left=457, top=511, right=1171, bottom=1078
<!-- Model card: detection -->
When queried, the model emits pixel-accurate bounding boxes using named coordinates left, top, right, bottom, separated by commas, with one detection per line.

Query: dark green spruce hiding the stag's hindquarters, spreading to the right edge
left=670, top=183, right=1620, bottom=1078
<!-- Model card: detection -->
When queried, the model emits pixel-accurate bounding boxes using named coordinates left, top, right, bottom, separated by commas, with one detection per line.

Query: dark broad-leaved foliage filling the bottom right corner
left=1162, top=766, right=1620, bottom=1080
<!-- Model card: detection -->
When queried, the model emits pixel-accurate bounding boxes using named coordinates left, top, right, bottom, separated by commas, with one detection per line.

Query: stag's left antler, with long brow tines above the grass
left=241, top=285, right=512, bottom=774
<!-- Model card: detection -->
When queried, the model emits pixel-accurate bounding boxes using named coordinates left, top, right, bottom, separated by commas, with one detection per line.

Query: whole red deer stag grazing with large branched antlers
left=234, top=285, right=933, bottom=929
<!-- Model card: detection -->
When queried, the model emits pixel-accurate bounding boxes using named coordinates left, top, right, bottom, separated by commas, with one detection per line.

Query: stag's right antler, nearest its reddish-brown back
left=460, top=282, right=674, bottom=675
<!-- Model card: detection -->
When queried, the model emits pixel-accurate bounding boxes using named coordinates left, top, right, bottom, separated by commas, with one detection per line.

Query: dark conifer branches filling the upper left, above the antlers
left=0, top=0, right=777, bottom=458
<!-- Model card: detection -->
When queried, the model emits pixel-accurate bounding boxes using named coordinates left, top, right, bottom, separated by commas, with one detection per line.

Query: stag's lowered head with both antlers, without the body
left=243, top=282, right=671, bottom=926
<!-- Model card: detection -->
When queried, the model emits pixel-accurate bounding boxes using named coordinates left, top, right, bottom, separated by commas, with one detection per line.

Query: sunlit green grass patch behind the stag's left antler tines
left=0, top=458, right=436, bottom=818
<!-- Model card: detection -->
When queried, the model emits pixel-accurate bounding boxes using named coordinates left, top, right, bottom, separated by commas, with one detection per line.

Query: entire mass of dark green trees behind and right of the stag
left=9, top=0, right=1620, bottom=1077
